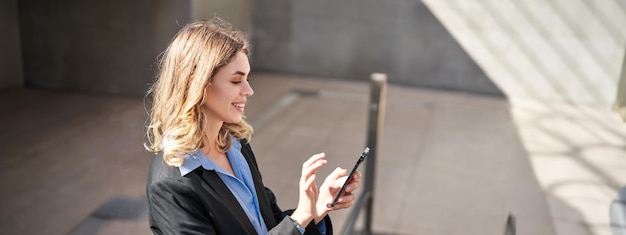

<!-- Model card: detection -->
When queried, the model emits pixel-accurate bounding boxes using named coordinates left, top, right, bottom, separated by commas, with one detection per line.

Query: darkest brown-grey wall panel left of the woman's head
left=19, top=0, right=190, bottom=95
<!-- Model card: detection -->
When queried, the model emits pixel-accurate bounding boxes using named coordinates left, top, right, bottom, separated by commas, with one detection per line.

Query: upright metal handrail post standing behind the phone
left=342, top=73, right=387, bottom=235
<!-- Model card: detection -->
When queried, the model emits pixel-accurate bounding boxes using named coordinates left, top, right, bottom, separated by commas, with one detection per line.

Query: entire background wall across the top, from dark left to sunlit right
left=0, top=0, right=626, bottom=103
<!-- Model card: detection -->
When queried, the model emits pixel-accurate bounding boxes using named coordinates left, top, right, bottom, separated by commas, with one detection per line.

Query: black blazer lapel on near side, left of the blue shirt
left=197, top=170, right=256, bottom=234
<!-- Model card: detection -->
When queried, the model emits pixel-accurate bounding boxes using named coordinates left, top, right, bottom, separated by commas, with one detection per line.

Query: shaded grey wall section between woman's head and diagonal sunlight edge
left=253, top=0, right=501, bottom=94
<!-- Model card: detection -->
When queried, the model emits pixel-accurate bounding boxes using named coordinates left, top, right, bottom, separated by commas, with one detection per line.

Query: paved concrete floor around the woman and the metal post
left=0, top=73, right=626, bottom=235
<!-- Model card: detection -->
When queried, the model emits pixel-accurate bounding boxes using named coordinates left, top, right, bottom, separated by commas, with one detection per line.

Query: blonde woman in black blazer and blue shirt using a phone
left=146, top=19, right=359, bottom=235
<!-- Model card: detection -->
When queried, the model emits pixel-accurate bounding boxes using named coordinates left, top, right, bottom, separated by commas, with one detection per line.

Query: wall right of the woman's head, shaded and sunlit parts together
left=253, top=0, right=626, bottom=106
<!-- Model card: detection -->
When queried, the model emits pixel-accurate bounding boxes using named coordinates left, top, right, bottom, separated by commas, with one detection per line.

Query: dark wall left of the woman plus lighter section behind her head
left=0, top=0, right=252, bottom=95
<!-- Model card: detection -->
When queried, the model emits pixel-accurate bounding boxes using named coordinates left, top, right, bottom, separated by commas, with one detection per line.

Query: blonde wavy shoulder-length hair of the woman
left=144, top=18, right=253, bottom=167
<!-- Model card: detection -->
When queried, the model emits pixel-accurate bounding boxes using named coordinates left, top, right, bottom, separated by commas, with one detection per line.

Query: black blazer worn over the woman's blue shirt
left=146, top=140, right=332, bottom=235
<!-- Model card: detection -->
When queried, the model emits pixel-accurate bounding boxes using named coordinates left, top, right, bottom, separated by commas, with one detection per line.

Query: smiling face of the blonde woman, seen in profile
left=204, top=52, right=254, bottom=123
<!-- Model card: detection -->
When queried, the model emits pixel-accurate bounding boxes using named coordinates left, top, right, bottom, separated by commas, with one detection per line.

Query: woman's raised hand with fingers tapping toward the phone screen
left=291, top=153, right=327, bottom=228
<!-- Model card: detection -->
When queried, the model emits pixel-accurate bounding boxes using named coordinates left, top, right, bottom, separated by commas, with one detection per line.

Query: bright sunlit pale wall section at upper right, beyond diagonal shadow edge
left=424, top=0, right=626, bottom=104
